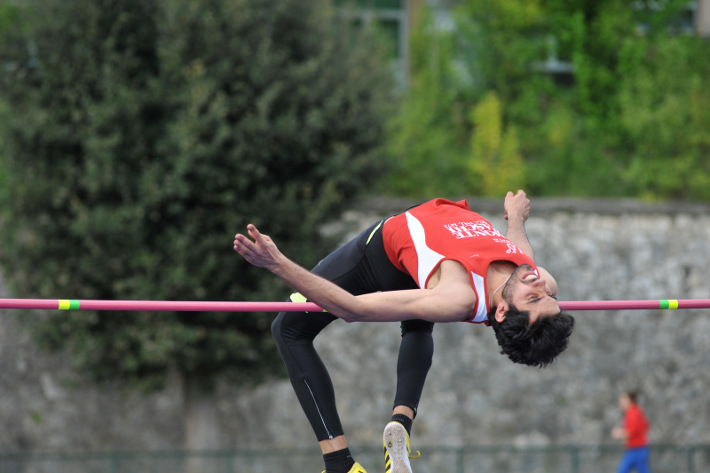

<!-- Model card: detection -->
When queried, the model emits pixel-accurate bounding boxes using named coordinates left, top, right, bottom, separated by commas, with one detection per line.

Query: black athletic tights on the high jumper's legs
left=271, top=222, right=434, bottom=441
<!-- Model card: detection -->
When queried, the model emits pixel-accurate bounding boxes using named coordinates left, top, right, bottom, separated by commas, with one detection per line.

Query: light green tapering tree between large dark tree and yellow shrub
left=382, top=5, right=470, bottom=196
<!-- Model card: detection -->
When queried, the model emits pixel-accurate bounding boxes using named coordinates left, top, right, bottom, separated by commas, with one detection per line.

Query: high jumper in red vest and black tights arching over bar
left=234, top=190, right=574, bottom=473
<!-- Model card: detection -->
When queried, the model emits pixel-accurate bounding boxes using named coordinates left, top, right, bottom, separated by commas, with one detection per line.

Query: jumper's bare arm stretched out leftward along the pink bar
left=234, top=224, right=476, bottom=322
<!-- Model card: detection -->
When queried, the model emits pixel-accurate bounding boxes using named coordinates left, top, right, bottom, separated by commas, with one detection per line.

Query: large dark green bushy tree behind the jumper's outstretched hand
left=0, top=0, right=391, bottom=447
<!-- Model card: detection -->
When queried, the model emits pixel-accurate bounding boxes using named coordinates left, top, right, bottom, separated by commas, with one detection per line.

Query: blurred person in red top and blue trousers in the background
left=611, top=391, right=651, bottom=473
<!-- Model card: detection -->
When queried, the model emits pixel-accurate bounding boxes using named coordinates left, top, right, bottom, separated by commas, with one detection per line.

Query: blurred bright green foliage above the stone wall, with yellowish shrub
left=381, top=0, right=710, bottom=200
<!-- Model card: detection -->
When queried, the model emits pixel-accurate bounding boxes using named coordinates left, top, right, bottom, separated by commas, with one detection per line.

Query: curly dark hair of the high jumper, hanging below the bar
left=488, top=304, right=574, bottom=368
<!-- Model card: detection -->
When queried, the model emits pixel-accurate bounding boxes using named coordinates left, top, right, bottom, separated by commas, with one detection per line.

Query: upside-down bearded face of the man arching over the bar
left=502, top=264, right=560, bottom=324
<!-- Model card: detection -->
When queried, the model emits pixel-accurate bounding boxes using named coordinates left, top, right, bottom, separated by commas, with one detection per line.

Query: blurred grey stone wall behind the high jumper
left=0, top=199, right=710, bottom=452
